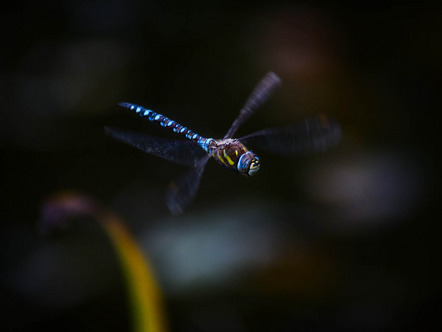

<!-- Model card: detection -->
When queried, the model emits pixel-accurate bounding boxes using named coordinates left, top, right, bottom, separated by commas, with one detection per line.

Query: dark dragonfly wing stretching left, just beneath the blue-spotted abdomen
left=105, top=127, right=207, bottom=167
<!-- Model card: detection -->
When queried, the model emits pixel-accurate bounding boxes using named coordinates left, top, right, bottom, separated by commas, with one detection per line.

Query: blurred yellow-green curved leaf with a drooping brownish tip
left=42, top=193, right=165, bottom=332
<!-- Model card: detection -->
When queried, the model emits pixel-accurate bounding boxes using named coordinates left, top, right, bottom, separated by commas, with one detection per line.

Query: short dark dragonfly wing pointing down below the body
left=166, top=156, right=210, bottom=214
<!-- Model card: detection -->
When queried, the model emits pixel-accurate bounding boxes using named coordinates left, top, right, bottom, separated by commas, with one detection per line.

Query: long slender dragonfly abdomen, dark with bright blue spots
left=119, top=103, right=214, bottom=153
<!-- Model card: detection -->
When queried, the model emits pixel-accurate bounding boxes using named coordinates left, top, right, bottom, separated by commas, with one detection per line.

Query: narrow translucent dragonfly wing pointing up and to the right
left=224, top=72, right=281, bottom=139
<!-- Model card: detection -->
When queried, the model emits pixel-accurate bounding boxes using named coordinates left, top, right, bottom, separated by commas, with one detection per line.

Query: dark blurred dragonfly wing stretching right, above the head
left=239, top=115, right=341, bottom=154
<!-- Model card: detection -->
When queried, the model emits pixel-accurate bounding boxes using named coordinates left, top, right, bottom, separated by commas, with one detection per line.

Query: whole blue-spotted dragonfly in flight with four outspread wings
left=105, top=72, right=341, bottom=214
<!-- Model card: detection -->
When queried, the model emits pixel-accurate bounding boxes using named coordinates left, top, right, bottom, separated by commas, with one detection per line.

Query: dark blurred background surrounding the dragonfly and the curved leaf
left=0, top=0, right=442, bottom=331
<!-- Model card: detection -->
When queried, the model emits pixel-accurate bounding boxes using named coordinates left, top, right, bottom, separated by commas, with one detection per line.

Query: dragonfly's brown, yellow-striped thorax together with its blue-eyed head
left=209, top=138, right=260, bottom=176
